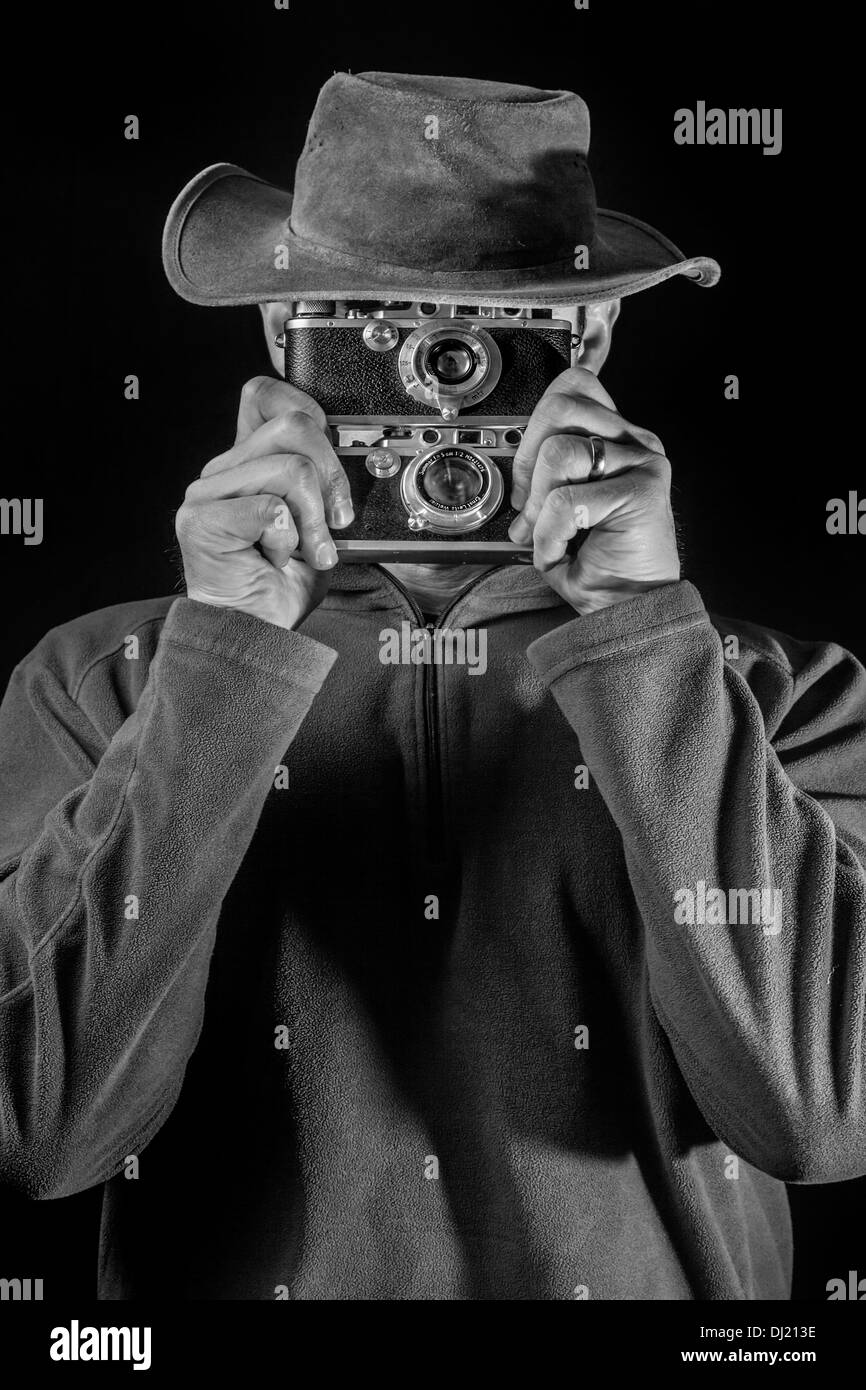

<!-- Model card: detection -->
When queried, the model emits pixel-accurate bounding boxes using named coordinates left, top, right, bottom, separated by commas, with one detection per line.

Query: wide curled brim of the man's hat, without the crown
left=163, top=164, right=721, bottom=307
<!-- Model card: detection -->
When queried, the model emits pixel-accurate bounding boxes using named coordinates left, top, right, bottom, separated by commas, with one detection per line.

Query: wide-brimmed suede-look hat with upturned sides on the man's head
left=163, top=72, right=720, bottom=306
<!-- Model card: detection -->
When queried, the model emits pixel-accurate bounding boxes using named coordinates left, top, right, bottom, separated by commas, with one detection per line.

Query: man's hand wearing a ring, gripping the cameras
left=509, top=367, right=680, bottom=613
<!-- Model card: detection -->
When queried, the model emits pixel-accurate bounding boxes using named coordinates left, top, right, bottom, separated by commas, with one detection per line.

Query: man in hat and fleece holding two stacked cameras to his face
left=0, top=74, right=866, bottom=1300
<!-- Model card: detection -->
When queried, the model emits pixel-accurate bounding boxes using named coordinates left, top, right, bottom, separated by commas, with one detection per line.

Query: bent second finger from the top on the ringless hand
left=186, top=453, right=336, bottom=570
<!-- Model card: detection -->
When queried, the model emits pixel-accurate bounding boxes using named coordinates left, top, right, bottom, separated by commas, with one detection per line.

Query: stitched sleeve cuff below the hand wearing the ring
left=527, top=580, right=710, bottom=685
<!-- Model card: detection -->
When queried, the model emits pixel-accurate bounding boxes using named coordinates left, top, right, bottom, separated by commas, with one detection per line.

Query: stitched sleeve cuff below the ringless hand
left=161, top=598, right=336, bottom=694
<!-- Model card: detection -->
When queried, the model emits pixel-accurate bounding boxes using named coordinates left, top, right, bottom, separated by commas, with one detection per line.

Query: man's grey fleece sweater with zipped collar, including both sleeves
left=0, top=567, right=866, bottom=1300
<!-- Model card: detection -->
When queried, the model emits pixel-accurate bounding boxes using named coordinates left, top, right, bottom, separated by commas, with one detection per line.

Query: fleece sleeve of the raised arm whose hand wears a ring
left=528, top=582, right=866, bottom=1182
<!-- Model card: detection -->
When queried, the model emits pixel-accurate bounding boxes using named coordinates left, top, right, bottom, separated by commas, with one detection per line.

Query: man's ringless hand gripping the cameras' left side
left=175, top=377, right=354, bottom=627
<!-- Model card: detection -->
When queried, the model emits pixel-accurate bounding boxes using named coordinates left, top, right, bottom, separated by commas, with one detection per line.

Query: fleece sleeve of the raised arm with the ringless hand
left=0, top=598, right=336, bottom=1197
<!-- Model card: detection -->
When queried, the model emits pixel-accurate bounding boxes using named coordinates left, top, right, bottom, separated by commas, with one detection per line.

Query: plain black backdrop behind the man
left=0, top=0, right=866, bottom=1298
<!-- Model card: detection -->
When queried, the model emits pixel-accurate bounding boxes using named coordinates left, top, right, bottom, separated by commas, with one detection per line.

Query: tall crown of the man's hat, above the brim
left=289, top=72, right=596, bottom=272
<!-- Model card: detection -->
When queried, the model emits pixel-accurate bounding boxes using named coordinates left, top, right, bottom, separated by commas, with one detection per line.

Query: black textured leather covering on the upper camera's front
left=285, top=321, right=571, bottom=418
